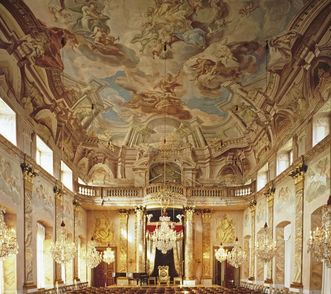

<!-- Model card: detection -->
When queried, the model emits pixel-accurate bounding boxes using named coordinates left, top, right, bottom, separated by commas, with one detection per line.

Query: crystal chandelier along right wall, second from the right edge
left=255, top=223, right=277, bottom=262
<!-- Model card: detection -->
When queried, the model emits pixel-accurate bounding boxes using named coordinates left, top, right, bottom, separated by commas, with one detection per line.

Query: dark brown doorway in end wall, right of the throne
left=213, top=246, right=240, bottom=288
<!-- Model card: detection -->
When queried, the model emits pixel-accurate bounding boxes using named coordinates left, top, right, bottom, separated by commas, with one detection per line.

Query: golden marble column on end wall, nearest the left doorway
left=117, top=209, right=129, bottom=272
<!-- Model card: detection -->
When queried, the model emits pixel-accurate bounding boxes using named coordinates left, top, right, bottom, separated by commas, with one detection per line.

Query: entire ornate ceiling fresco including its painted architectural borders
left=0, top=0, right=331, bottom=183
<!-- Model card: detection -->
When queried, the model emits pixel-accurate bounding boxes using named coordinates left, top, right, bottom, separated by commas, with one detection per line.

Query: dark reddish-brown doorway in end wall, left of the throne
left=91, top=247, right=116, bottom=287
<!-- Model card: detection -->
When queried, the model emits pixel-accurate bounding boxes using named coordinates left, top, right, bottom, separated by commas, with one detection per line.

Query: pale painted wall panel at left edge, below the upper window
left=0, top=154, right=22, bottom=204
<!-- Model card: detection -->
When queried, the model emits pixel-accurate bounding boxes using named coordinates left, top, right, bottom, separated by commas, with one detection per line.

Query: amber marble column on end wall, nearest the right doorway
left=201, top=210, right=212, bottom=279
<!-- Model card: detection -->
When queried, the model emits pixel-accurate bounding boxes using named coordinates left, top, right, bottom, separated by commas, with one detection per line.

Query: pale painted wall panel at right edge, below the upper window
left=305, top=155, right=330, bottom=202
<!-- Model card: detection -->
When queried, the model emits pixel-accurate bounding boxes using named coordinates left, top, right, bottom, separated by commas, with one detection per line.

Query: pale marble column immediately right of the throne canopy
left=184, top=207, right=194, bottom=280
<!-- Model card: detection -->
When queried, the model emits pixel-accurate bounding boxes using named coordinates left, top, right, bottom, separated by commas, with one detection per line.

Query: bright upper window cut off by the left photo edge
left=0, top=98, right=17, bottom=145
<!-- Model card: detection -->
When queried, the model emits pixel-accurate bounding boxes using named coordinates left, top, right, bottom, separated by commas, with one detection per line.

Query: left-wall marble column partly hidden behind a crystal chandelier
left=53, top=185, right=63, bottom=284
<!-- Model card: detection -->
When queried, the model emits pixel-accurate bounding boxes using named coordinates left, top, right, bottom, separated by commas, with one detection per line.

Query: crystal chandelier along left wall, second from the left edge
left=51, top=221, right=76, bottom=264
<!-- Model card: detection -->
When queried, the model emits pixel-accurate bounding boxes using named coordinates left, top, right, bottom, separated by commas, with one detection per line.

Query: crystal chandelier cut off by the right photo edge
left=308, top=195, right=331, bottom=267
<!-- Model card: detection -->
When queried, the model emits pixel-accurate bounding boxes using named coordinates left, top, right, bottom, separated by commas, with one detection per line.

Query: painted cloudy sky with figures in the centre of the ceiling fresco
left=25, top=0, right=303, bottom=143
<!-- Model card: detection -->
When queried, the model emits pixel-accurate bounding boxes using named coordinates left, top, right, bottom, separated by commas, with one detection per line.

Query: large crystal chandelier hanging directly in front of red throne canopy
left=151, top=212, right=181, bottom=254
